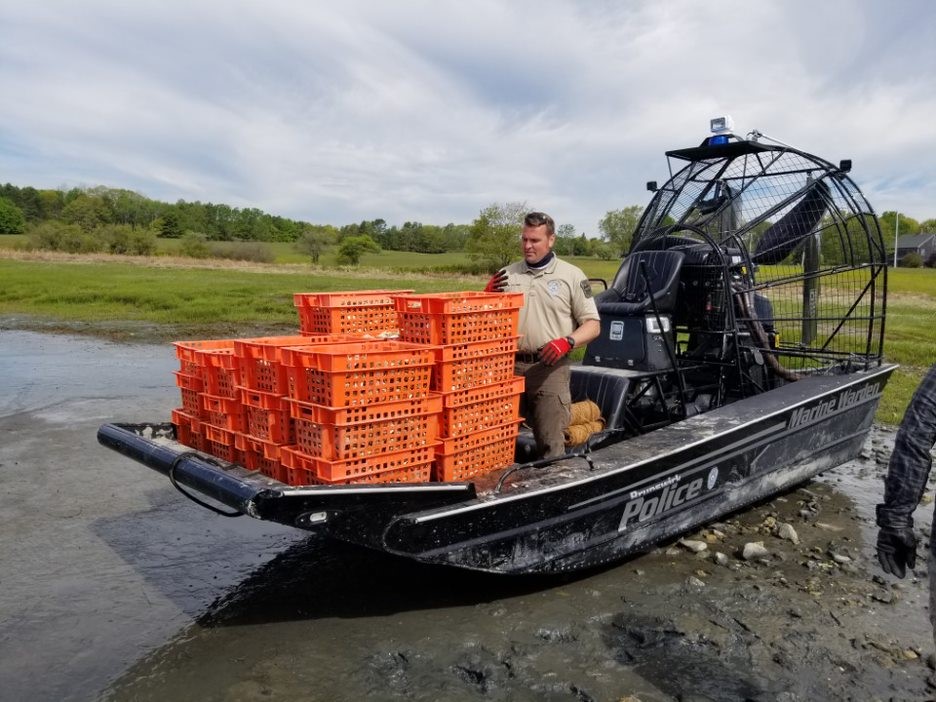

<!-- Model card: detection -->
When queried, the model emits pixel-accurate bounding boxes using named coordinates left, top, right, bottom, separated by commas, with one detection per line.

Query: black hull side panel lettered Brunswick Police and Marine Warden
left=383, top=366, right=893, bottom=573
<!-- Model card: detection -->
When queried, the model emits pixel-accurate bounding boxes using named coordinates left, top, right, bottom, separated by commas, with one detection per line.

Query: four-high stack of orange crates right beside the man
left=394, top=292, right=523, bottom=481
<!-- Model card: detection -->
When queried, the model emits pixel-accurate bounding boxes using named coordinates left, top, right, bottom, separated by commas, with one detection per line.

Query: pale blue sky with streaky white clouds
left=0, top=0, right=936, bottom=235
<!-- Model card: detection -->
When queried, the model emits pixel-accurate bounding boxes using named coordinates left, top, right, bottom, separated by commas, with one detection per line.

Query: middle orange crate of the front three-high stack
left=291, top=395, right=442, bottom=460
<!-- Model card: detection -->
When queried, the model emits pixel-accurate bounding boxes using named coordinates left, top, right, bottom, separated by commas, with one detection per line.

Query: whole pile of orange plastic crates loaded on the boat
left=172, top=290, right=523, bottom=485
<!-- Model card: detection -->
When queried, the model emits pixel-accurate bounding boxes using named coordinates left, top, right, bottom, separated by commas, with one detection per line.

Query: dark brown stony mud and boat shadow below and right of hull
left=105, top=427, right=933, bottom=702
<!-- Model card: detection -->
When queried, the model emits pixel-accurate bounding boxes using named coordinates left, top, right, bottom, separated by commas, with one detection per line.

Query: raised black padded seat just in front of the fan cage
left=595, top=250, right=685, bottom=317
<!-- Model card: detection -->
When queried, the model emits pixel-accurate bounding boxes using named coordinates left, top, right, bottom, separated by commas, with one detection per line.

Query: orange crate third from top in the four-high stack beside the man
left=442, top=376, right=524, bottom=437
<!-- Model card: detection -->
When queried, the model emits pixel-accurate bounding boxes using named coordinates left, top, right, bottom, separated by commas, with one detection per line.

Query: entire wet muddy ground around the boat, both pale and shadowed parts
left=0, top=332, right=933, bottom=702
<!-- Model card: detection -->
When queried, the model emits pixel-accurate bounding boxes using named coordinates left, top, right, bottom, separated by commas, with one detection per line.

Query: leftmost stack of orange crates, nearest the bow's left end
left=172, top=339, right=244, bottom=462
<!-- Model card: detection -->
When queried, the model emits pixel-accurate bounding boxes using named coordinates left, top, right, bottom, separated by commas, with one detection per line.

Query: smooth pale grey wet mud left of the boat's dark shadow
left=0, top=331, right=295, bottom=700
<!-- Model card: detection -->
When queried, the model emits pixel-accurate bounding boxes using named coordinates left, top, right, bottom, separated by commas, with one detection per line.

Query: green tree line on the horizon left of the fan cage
left=0, top=183, right=641, bottom=267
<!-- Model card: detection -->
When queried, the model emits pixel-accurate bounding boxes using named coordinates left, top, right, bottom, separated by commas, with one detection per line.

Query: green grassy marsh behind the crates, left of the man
left=0, top=257, right=478, bottom=339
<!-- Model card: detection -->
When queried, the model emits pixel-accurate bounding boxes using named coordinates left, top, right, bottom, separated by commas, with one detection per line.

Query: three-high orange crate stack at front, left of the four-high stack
left=280, top=340, right=442, bottom=485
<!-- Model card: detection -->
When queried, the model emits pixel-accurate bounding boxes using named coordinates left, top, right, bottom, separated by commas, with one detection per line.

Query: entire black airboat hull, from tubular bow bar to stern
left=99, top=366, right=895, bottom=574
